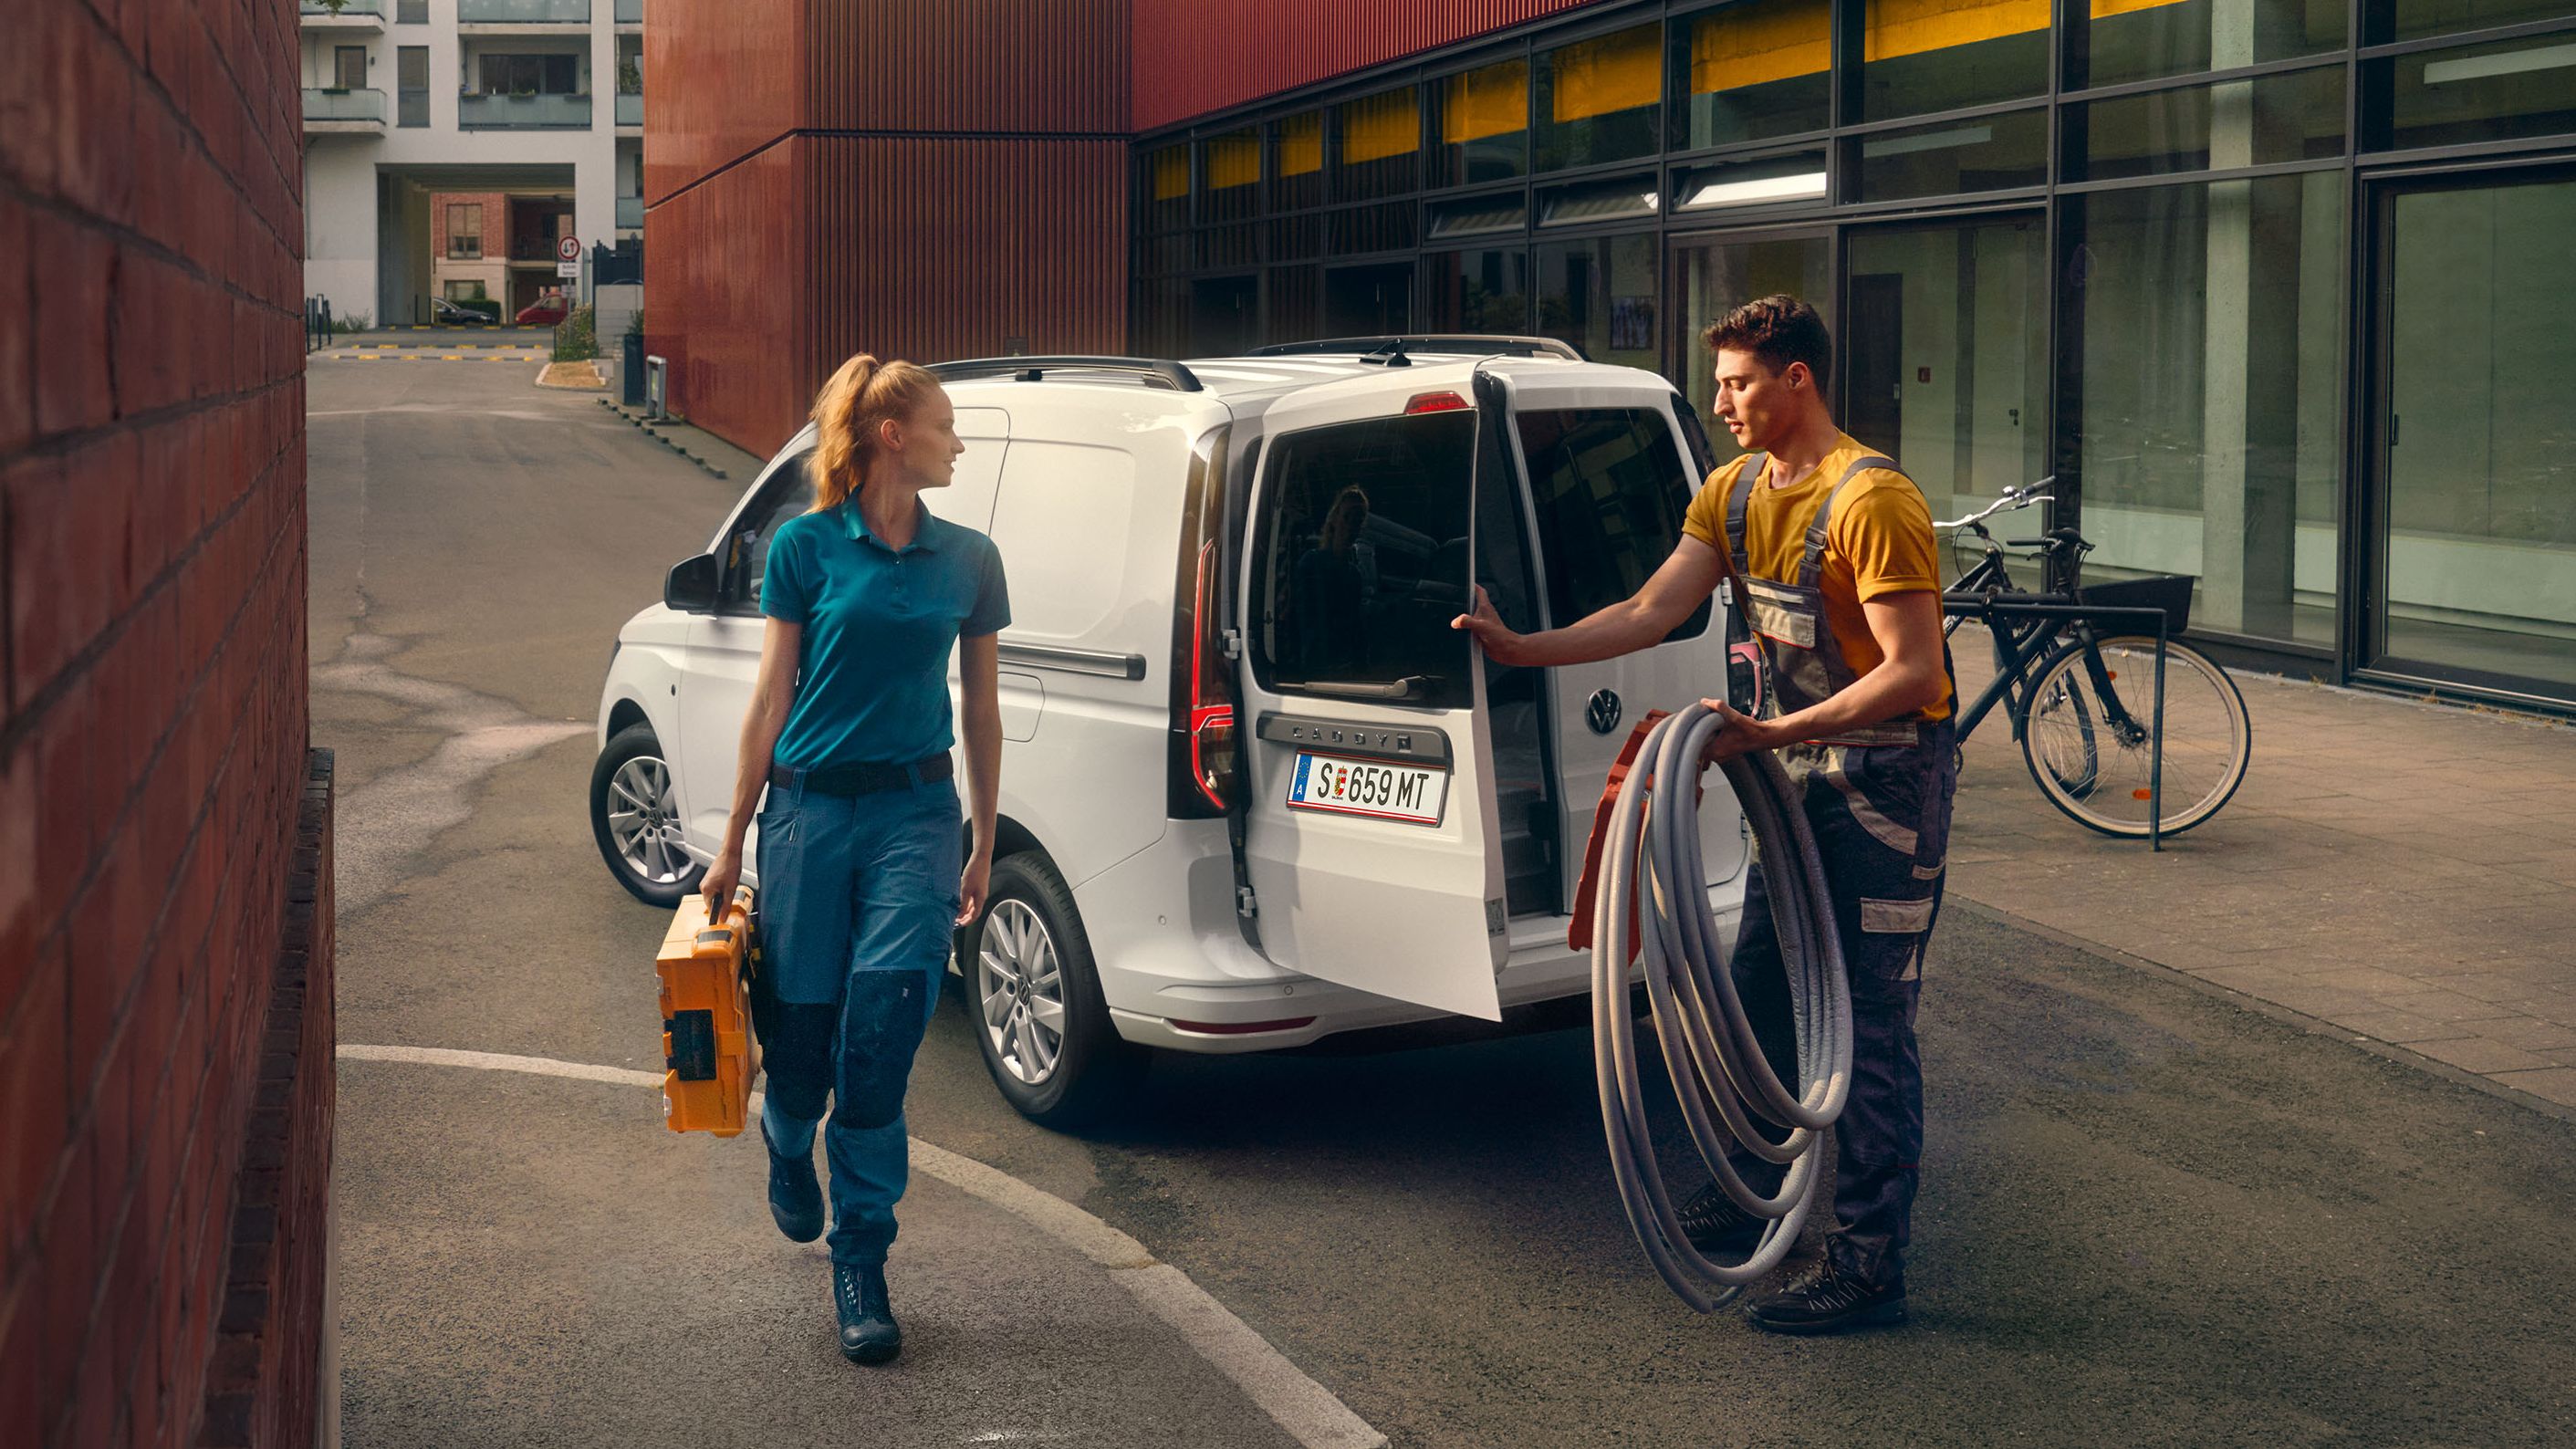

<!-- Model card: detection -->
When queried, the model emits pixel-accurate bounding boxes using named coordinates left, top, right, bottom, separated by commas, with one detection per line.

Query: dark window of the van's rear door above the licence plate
left=1252, top=412, right=1476, bottom=710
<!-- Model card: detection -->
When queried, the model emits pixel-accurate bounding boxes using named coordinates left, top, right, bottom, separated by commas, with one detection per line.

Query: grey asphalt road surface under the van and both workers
left=309, top=360, right=2576, bottom=1446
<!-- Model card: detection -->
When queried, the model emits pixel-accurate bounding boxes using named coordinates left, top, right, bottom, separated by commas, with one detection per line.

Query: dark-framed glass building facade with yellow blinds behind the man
left=1131, top=0, right=2576, bottom=710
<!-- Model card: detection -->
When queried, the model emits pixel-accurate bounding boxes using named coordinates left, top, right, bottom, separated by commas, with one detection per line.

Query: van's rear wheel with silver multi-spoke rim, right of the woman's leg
left=958, top=850, right=1149, bottom=1127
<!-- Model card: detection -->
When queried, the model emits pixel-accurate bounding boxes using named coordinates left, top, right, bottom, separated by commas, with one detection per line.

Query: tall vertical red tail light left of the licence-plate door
left=1164, top=427, right=1236, bottom=821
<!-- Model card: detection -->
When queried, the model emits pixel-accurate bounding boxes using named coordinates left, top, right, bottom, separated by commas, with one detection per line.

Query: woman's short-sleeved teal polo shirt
left=760, top=502, right=1010, bottom=769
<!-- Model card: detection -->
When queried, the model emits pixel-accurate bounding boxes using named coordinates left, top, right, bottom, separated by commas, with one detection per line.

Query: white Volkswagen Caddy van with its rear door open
left=589, top=337, right=1747, bottom=1122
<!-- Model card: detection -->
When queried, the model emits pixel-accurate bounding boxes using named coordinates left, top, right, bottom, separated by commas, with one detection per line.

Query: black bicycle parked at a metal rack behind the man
left=1932, top=476, right=2254, bottom=839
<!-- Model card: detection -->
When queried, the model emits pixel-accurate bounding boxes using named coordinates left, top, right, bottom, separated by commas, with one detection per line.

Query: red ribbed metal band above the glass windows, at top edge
left=1128, top=0, right=1594, bottom=131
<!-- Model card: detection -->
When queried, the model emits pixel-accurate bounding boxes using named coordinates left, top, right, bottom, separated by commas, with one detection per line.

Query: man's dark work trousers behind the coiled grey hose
left=1731, top=721, right=1957, bottom=1284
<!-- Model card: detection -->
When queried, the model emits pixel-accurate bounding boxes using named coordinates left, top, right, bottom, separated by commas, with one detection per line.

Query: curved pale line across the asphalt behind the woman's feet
left=340, top=1042, right=1386, bottom=1449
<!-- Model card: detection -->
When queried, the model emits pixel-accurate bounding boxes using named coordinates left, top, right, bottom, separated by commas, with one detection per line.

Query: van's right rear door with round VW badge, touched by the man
left=1494, top=363, right=1747, bottom=901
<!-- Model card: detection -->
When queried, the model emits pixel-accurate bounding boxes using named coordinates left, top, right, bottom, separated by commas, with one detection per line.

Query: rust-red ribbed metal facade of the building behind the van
left=644, top=0, right=1587, bottom=453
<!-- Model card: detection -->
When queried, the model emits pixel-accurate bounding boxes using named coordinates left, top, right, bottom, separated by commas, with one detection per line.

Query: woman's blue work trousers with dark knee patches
left=757, top=780, right=966, bottom=1264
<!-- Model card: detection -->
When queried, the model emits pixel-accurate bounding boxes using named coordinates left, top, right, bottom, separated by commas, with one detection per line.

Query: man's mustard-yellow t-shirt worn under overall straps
left=1682, top=435, right=1950, bottom=721
